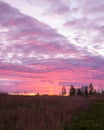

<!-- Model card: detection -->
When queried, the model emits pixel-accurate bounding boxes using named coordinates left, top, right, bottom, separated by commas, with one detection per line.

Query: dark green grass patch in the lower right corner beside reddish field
left=68, top=101, right=104, bottom=130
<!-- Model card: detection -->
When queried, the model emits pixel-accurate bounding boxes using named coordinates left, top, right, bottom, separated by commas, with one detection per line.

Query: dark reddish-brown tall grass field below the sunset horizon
left=0, top=94, right=104, bottom=130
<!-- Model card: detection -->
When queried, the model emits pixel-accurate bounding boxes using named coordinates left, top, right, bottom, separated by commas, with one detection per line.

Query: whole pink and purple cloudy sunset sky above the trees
left=0, top=0, right=104, bottom=94
